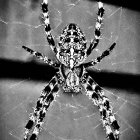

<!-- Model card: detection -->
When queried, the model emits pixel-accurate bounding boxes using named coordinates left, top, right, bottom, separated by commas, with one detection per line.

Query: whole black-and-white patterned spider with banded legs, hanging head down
left=22, top=0, right=120, bottom=140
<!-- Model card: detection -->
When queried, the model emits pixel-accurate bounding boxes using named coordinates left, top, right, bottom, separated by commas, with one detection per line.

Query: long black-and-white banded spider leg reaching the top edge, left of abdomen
left=42, top=0, right=57, bottom=53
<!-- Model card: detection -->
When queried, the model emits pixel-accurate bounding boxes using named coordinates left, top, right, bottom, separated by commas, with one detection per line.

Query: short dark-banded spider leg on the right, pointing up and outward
left=82, top=42, right=116, bottom=68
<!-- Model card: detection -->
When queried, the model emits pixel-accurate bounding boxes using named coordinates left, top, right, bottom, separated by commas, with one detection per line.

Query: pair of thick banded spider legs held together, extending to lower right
left=82, top=73, right=120, bottom=140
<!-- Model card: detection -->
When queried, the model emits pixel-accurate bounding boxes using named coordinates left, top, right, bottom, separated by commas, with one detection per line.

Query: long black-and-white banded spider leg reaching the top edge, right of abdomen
left=87, top=0, right=105, bottom=56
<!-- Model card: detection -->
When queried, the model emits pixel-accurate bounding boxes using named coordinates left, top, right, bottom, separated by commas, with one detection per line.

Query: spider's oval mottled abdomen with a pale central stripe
left=56, top=23, right=86, bottom=69
